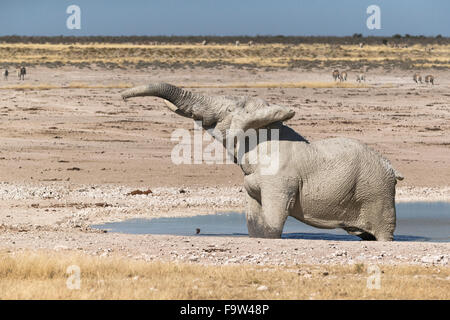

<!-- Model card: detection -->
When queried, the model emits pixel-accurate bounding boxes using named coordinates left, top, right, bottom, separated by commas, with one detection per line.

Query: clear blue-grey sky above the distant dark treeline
left=0, top=0, right=450, bottom=37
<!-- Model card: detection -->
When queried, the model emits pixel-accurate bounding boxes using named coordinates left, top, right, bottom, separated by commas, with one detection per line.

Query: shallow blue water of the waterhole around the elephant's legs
left=93, top=202, right=450, bottom=242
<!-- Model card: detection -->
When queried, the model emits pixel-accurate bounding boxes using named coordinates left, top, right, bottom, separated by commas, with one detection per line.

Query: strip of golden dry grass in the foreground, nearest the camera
left=0, top=252, right=450, bottom=299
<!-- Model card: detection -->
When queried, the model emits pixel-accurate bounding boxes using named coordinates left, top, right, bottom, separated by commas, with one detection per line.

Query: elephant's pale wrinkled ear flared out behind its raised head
left=230, top=104, right=295, bottom=132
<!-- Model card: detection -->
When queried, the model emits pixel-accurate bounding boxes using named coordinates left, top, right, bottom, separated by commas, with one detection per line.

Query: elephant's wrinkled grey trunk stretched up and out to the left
left=122, top=83, right=219, bottom=126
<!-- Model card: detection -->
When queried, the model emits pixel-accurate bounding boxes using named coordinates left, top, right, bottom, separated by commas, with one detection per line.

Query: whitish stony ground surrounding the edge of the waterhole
left=0, top=183, right=450, bottom=266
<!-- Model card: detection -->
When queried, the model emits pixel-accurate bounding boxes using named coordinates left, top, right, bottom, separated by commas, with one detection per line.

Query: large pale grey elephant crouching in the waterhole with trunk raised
left=122, top=83, right=403, bottom=241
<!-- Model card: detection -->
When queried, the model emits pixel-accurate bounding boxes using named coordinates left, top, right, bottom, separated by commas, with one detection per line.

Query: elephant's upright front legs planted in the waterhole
left=247, top=179, right=298, bottom=238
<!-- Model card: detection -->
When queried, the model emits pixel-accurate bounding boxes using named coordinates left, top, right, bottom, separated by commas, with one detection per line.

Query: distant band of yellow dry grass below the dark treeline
left=0, top=43, right=450, bottom=68
